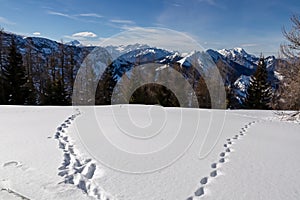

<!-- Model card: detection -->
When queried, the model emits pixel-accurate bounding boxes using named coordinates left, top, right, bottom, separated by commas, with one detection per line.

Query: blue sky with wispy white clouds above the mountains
left=0, top=0, right=300, bottom=55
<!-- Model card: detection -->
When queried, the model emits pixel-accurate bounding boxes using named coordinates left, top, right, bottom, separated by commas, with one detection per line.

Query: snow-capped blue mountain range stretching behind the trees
left=3, top=33, right=278, bottom=107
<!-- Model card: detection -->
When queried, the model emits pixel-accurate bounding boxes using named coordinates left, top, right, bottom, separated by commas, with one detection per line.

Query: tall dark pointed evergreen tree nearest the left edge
left=3, top=37, right=29, bottom=105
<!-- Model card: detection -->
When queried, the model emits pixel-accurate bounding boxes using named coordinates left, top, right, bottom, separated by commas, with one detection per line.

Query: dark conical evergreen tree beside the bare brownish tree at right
left=244, top=57, right=272, bottom=110
